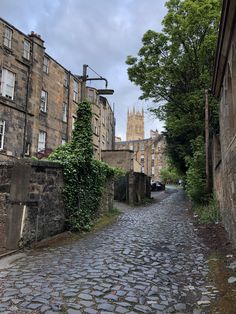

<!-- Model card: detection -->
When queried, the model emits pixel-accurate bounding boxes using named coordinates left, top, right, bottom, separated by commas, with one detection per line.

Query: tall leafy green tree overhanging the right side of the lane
left=126, top=0, right=221, bottom=201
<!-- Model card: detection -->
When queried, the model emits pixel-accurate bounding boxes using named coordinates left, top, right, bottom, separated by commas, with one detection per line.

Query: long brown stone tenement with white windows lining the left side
left=0, top=18, right=115, bottom=159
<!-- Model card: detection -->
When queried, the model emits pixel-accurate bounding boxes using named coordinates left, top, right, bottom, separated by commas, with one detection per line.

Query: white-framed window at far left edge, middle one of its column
left=0, top=68, right=16, bottom=100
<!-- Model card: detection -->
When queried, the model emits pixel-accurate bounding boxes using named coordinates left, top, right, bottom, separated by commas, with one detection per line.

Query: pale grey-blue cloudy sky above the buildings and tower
left=0, top=0, right=166, bottom=140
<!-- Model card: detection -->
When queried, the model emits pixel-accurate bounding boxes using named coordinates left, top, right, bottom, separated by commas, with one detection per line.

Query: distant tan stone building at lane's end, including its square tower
left=115, top=109, right=166, bottom=181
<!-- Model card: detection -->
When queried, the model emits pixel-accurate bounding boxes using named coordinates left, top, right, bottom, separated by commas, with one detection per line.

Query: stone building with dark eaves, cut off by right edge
left=212, top=0, right=236, bottom=245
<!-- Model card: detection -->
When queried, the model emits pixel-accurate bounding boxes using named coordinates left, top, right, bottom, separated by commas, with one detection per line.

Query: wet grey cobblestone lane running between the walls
left=0, top=190, right=217, bottom=314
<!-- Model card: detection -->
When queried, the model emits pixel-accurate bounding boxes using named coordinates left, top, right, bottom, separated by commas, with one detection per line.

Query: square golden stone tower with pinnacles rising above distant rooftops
left=126, top=107, right=144, bottom=141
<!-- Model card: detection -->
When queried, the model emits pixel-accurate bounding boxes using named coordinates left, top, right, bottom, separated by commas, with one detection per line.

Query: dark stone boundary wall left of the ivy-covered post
left=0, top=160, right=64, bottom=249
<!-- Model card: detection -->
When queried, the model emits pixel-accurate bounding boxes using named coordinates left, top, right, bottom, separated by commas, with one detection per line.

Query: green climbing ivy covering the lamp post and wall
left=49, top=101, right=119, bottom=231
